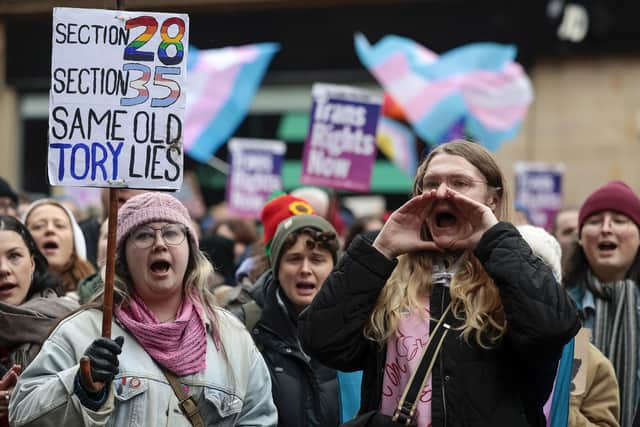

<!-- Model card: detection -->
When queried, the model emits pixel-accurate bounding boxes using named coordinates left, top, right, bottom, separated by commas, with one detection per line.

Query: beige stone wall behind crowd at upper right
left=497, top=57, right=640, bottom=210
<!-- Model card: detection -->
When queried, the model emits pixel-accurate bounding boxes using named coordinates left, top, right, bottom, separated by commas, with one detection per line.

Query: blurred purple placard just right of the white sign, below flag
left=226, top=138, right=286, bottom=218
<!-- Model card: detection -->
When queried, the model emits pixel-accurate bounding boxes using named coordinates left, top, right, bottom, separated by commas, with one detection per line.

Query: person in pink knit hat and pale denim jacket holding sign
left=9, top=193, right=277, bottom=427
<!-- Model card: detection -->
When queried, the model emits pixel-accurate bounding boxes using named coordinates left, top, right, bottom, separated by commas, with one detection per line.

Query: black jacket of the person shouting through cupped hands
left=298, top=223, right=580, bottom=427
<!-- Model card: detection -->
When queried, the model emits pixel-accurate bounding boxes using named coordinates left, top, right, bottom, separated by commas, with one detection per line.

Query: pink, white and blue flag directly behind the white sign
left=184, top=43, right=280, bottom=162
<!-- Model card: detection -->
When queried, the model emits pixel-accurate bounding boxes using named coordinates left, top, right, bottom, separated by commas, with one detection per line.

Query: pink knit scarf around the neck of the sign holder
left=115, top=293, right=207, bottom=376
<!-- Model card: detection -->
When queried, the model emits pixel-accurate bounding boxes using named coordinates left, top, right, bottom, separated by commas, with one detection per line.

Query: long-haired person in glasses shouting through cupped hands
left=298, top=140, right=580, bottom=427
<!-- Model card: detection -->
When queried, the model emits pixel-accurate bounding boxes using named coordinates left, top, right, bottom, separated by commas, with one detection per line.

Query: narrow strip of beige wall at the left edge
left=0, top=18, right=20, bottom=188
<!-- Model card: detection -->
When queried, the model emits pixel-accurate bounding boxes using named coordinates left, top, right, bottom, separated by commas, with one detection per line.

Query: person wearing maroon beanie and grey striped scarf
left=564, top=181, right=640, bottom=426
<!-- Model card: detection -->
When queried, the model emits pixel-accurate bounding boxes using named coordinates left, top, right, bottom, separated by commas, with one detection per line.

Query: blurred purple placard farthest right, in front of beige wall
left=515, top=162, right=564, bottom=230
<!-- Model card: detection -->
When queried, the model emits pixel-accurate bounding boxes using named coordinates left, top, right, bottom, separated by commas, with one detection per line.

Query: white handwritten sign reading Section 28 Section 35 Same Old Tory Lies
left=48, top=8, right=189, bottom=189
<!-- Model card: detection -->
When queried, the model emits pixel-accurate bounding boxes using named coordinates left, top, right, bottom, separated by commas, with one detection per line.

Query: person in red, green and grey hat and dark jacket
left=238, top=194, right=340, bottom=427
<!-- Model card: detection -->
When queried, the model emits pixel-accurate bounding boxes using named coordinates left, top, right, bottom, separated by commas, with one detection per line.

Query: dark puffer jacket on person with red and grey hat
left=251, top=274, right=340, bottom=427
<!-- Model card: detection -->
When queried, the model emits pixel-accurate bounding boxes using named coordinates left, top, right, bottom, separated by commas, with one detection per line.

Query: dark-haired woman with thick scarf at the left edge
left=0, top=215, right=77, bottom=425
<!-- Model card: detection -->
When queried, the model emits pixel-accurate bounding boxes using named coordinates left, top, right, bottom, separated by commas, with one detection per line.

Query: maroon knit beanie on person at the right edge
left=578, top=181, right=640, bottom=234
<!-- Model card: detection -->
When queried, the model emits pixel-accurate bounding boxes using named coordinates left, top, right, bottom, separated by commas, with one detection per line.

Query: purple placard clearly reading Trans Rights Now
left=300, top=83, right=382, bottom=192
